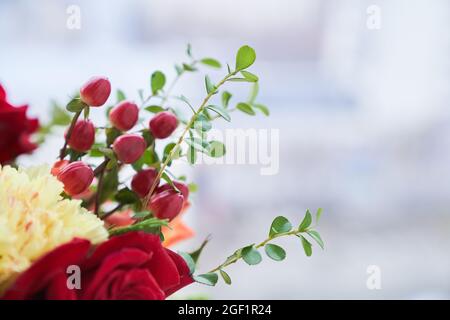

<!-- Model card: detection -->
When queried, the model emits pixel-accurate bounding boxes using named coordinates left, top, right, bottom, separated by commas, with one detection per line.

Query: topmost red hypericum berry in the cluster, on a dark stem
left=80, top=77, right=111, bottom=107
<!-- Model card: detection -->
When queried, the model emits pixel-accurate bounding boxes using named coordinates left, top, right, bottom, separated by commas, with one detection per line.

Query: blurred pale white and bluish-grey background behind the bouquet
left=0, top=0, right=450, bottom=299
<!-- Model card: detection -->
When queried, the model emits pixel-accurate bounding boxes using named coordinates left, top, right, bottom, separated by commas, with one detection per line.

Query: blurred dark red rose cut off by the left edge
left=0, top=85, right=39, bottom=164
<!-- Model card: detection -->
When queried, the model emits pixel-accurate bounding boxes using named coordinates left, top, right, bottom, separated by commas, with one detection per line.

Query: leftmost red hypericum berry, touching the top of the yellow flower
left=57, top=161, right=94, bottom=196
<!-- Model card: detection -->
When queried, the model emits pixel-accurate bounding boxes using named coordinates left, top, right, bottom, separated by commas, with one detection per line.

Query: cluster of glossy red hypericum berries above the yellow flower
left=52, top=77, right=185, bottom=220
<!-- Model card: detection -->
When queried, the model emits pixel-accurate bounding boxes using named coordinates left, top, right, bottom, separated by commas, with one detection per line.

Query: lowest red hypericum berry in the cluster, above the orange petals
left=148, top=190, right=184, bottom=220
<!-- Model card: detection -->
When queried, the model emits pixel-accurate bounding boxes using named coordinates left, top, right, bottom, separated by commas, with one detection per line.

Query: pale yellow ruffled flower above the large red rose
left=0, top=166, right=108, bottom=292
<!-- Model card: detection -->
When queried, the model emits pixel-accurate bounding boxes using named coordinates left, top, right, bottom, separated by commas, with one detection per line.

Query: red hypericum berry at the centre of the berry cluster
left=113, top=134, right=147, bottom=164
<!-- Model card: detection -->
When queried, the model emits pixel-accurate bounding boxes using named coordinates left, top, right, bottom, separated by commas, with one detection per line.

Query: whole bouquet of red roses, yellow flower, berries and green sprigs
left=0, top=46, right=323, bottom=300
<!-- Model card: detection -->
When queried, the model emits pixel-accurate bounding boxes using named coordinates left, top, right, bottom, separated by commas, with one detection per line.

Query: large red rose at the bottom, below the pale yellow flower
left=3, top=232, right=193, bottom=300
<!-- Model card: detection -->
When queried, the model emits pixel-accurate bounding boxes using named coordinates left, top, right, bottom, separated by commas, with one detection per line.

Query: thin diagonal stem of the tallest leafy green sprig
left=142, top=70, right=239, bottom=209
